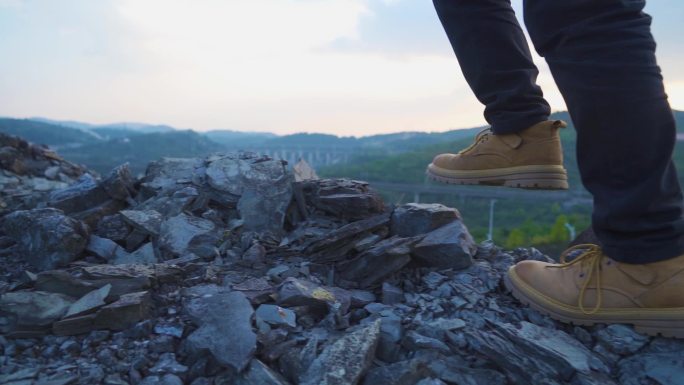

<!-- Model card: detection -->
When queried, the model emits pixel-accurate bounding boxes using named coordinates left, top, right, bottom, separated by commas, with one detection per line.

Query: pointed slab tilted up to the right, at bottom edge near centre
left=300, top=320, right=380, bottom=385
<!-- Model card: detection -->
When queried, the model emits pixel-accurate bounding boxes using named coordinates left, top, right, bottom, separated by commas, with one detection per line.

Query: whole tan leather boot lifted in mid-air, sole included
left=427, top=120, right=568, bottom=190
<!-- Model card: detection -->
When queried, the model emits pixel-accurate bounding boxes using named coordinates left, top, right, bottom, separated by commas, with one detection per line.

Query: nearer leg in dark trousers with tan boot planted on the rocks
left=505, top=0, right=684, bottom=338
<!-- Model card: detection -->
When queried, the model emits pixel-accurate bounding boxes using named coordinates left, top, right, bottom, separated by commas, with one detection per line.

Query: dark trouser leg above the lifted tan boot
left=433, top=0, right=556, bottom=134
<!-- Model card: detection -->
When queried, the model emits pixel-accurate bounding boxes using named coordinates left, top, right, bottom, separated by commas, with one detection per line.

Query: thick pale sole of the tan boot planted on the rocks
left=504, top=267, right=684, bottom=338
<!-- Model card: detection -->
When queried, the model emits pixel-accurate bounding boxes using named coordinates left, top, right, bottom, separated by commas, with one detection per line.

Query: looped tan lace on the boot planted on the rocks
left=547, top=244, right=607, bottom=315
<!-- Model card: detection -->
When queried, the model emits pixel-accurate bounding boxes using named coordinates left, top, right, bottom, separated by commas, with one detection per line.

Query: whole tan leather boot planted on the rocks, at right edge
left=505, top=245, right=684, bottom=338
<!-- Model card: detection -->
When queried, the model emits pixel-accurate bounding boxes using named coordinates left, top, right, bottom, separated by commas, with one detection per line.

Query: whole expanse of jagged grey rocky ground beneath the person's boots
left=0, top=135, right=684, bottom=385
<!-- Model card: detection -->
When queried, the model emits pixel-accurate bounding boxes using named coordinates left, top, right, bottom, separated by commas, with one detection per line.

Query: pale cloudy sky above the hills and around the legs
left=0, top=0, right=684, bottom=136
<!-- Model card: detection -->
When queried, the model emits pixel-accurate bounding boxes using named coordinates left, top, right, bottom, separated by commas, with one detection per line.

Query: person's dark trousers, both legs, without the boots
left=434, top=0, right=684, bottom=263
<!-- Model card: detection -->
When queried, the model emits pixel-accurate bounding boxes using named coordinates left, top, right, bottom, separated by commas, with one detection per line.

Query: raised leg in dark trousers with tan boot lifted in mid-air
left=426, top=0, right=568, bottom=189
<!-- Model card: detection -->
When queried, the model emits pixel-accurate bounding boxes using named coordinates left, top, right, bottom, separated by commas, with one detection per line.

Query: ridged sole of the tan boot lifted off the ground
left=426, top=163, right=568, bottom=190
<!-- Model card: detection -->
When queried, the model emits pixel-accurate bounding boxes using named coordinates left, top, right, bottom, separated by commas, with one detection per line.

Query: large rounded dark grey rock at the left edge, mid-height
left=3, top=208, right=88, bottom=270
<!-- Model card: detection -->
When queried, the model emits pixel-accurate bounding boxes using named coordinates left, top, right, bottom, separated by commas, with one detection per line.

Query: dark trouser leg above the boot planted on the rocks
left=525, top=0, right=684, bottom=263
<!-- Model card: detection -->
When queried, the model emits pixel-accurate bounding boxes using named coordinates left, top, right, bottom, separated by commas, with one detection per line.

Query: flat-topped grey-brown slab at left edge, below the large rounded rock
left=0, top=291, right=74, bottom=333
